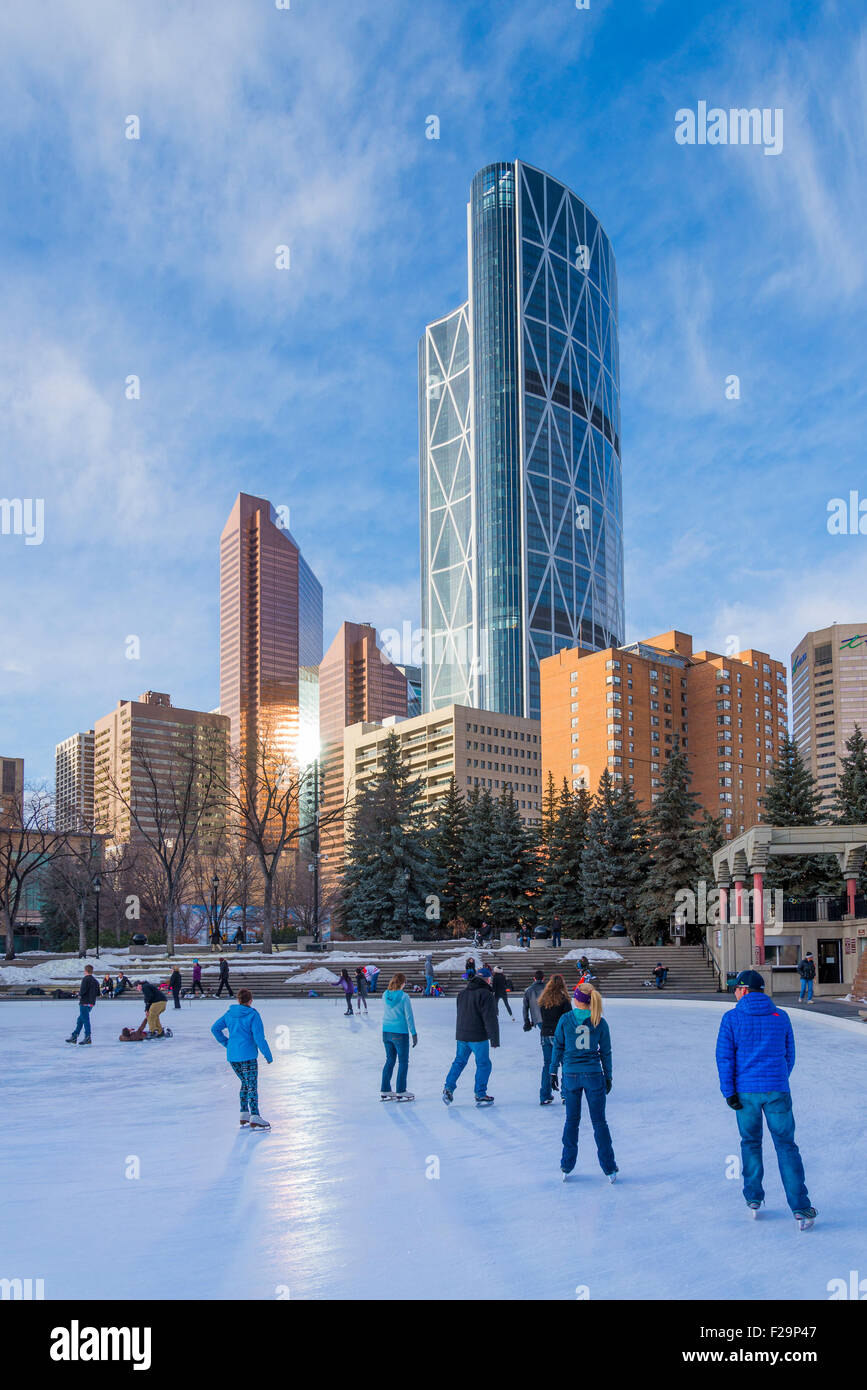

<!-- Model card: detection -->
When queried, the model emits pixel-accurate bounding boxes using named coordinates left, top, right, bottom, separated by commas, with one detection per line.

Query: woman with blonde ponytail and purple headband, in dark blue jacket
left=550, top=984, right=617, bottom=1183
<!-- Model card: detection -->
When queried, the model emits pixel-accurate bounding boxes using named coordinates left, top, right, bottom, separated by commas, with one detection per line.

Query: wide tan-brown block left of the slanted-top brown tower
left=93, top=691, right=229, bottom=844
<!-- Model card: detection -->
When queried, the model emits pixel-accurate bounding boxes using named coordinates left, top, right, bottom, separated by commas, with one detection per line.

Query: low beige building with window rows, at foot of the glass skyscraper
left=343, top=705, right=542, bottom=826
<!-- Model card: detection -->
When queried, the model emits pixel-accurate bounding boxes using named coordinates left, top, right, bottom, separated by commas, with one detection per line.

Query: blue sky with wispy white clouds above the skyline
left=0, top=0, right=867, bottom=781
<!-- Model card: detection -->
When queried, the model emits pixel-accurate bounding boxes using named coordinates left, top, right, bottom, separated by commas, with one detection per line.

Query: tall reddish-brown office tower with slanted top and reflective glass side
left=220, top=492, right=322, bottom=815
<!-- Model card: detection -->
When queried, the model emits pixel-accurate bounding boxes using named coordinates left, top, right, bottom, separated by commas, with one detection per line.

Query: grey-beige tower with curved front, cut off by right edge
left=792, top=623, right=867, bottom=813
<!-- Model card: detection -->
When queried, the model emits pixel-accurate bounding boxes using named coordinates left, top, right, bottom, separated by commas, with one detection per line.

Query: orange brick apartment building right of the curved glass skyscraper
left=542, top=631, right=788, bottom=835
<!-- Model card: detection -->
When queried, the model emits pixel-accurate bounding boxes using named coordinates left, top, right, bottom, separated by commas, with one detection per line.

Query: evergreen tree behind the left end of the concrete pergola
left=761, top=737, right=841, bottom=898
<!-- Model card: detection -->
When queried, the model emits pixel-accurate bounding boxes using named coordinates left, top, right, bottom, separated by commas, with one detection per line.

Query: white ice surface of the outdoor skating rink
left=0, top=995, right=867, bottom=1300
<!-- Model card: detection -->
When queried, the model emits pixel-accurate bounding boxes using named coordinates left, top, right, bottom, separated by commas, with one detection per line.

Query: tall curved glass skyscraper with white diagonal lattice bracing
left=418, top=160, right=624, bottom=719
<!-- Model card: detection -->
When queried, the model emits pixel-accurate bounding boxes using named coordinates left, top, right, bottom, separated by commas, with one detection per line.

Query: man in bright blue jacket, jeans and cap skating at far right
left=717, top=970, right=816, bottom=1230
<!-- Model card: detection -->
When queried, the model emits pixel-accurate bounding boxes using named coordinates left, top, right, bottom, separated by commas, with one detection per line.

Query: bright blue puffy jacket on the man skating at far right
left=717, top=990, right=795, bottom=1097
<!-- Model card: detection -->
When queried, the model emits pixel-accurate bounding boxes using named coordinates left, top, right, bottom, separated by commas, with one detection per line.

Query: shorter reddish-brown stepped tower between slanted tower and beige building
left=320, top=623, right=410, bottom=915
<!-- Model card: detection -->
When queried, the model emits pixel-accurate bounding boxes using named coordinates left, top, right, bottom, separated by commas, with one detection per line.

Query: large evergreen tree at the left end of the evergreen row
left=340, top=733, right=439, bottom=938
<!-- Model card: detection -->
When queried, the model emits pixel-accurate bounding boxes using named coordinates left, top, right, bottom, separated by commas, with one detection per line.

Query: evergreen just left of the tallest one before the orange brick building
left=581, top=767, right=647, bottom=940
